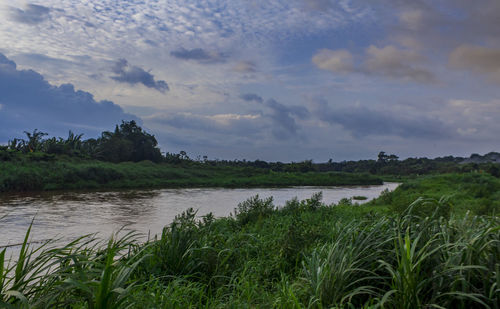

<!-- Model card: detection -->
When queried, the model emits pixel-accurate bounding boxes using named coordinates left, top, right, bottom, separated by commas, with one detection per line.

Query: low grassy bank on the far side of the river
left=0, top=154, right=382, bottom=192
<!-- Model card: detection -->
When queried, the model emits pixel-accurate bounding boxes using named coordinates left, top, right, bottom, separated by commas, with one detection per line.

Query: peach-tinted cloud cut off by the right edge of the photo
left=449, top=45, right=500, bottom=82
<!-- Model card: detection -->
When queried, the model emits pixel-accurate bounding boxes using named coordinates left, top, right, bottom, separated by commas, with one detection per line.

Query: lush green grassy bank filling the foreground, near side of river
left=0, top=175, right=500, bottom=308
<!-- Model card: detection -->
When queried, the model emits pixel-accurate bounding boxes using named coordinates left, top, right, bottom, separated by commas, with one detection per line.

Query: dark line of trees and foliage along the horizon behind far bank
left=0, top=121, right=500, bottom=177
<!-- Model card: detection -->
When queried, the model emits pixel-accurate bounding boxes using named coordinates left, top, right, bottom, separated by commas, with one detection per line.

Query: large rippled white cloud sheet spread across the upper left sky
left=0, top=0, right=368, bottom=113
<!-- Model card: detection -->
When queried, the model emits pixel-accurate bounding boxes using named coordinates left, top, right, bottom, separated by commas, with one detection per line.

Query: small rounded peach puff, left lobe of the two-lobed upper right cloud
left=312, top=49, right=354, bottom=73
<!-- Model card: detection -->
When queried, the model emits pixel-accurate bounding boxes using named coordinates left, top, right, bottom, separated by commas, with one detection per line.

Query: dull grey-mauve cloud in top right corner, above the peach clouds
left=374, top=0, right=500, bottom=52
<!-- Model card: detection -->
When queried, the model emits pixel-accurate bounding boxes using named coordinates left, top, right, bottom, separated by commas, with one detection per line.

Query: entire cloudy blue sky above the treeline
left=0, top=0, right=500, bottom=162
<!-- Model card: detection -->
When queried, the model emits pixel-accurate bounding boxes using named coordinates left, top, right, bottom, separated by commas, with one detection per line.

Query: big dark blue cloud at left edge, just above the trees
left=0, top=53, right=140, bottom=142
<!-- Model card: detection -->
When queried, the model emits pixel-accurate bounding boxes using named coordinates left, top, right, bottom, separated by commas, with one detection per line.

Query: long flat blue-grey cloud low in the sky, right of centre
left=314, top=99, right=452, bottom=139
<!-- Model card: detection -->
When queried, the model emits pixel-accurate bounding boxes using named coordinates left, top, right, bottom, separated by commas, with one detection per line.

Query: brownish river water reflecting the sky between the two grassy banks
left=0, top=183, right=398, bottom=251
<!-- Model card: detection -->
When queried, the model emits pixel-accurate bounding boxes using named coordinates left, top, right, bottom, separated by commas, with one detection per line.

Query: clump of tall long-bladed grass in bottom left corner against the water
left=0, top=227, right=147, bottom=308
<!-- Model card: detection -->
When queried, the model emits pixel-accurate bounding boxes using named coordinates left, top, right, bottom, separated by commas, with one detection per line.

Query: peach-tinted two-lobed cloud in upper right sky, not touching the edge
left=312, top=45, right=435, bottom=83
